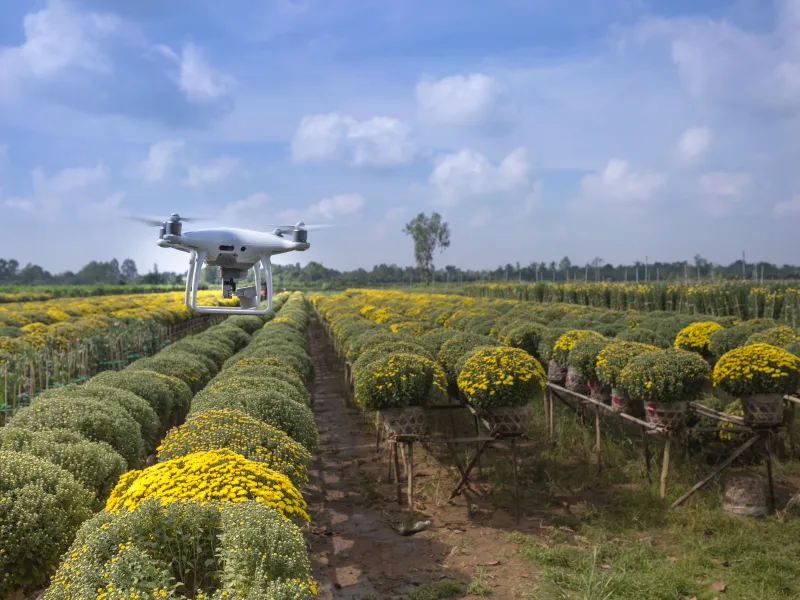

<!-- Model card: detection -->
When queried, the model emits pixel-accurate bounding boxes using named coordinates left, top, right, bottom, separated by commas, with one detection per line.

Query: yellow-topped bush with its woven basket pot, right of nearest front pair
left=458, top=347, right=547, bottom=434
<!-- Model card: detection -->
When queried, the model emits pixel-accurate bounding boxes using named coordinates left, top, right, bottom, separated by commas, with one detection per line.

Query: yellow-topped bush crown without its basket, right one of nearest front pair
left=458, top=347, right=547, bottom=408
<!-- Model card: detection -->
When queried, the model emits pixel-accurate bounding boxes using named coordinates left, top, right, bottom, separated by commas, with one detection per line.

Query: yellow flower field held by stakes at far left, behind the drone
left=0, top=292, right=237, bottom=412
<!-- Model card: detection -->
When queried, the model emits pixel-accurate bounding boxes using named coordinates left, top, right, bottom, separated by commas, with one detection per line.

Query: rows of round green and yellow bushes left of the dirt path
left=0, top=293, right=318, bottom=600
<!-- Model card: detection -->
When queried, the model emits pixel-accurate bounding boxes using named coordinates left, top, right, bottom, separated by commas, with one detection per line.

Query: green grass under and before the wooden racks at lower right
left=478, top=396, right=800, bottom=600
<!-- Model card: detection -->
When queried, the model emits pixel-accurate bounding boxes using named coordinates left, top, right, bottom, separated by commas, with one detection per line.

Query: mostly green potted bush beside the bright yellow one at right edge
left=619, top=349, right=711, bottom=429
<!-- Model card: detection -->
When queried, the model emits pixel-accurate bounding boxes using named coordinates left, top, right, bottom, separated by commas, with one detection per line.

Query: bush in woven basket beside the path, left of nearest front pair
left=355, top=352, right=447, bottom=436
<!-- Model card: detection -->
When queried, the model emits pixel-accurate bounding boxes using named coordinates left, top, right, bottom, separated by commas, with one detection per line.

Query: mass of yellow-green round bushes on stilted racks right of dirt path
left=312, top=290, right=800, bottom=432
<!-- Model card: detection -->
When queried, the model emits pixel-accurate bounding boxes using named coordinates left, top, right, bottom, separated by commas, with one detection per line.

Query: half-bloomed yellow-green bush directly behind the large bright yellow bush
left=158, top=410, right=311, bottom=488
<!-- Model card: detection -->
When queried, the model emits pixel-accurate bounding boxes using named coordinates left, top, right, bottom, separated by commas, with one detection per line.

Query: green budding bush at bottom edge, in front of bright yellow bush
left=44, top=499, right=317, bottom=600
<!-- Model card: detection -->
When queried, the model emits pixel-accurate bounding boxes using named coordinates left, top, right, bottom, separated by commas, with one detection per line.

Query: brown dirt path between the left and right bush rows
left=307, top=325, right=532, bottom=600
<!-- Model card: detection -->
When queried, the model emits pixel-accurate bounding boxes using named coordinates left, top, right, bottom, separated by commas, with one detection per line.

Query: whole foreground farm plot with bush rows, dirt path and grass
left=0, top=290, right=800, bottom=600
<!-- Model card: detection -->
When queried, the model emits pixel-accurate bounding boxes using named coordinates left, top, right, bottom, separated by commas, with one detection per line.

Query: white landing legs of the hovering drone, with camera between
left=184, top=251, right=272, bottom=315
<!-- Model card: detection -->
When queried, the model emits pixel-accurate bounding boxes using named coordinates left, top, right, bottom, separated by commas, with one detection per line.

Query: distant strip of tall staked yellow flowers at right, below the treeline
left=464, top=281, right=800, bottom=327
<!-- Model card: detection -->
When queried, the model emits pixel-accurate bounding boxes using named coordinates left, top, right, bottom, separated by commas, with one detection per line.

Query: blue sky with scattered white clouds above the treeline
left=0, top=0, right=800, bottom=272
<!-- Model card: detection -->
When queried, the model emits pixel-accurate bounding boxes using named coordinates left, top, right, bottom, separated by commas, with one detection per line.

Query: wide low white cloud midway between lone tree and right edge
left=581, top=158, right=667, bottom=205
